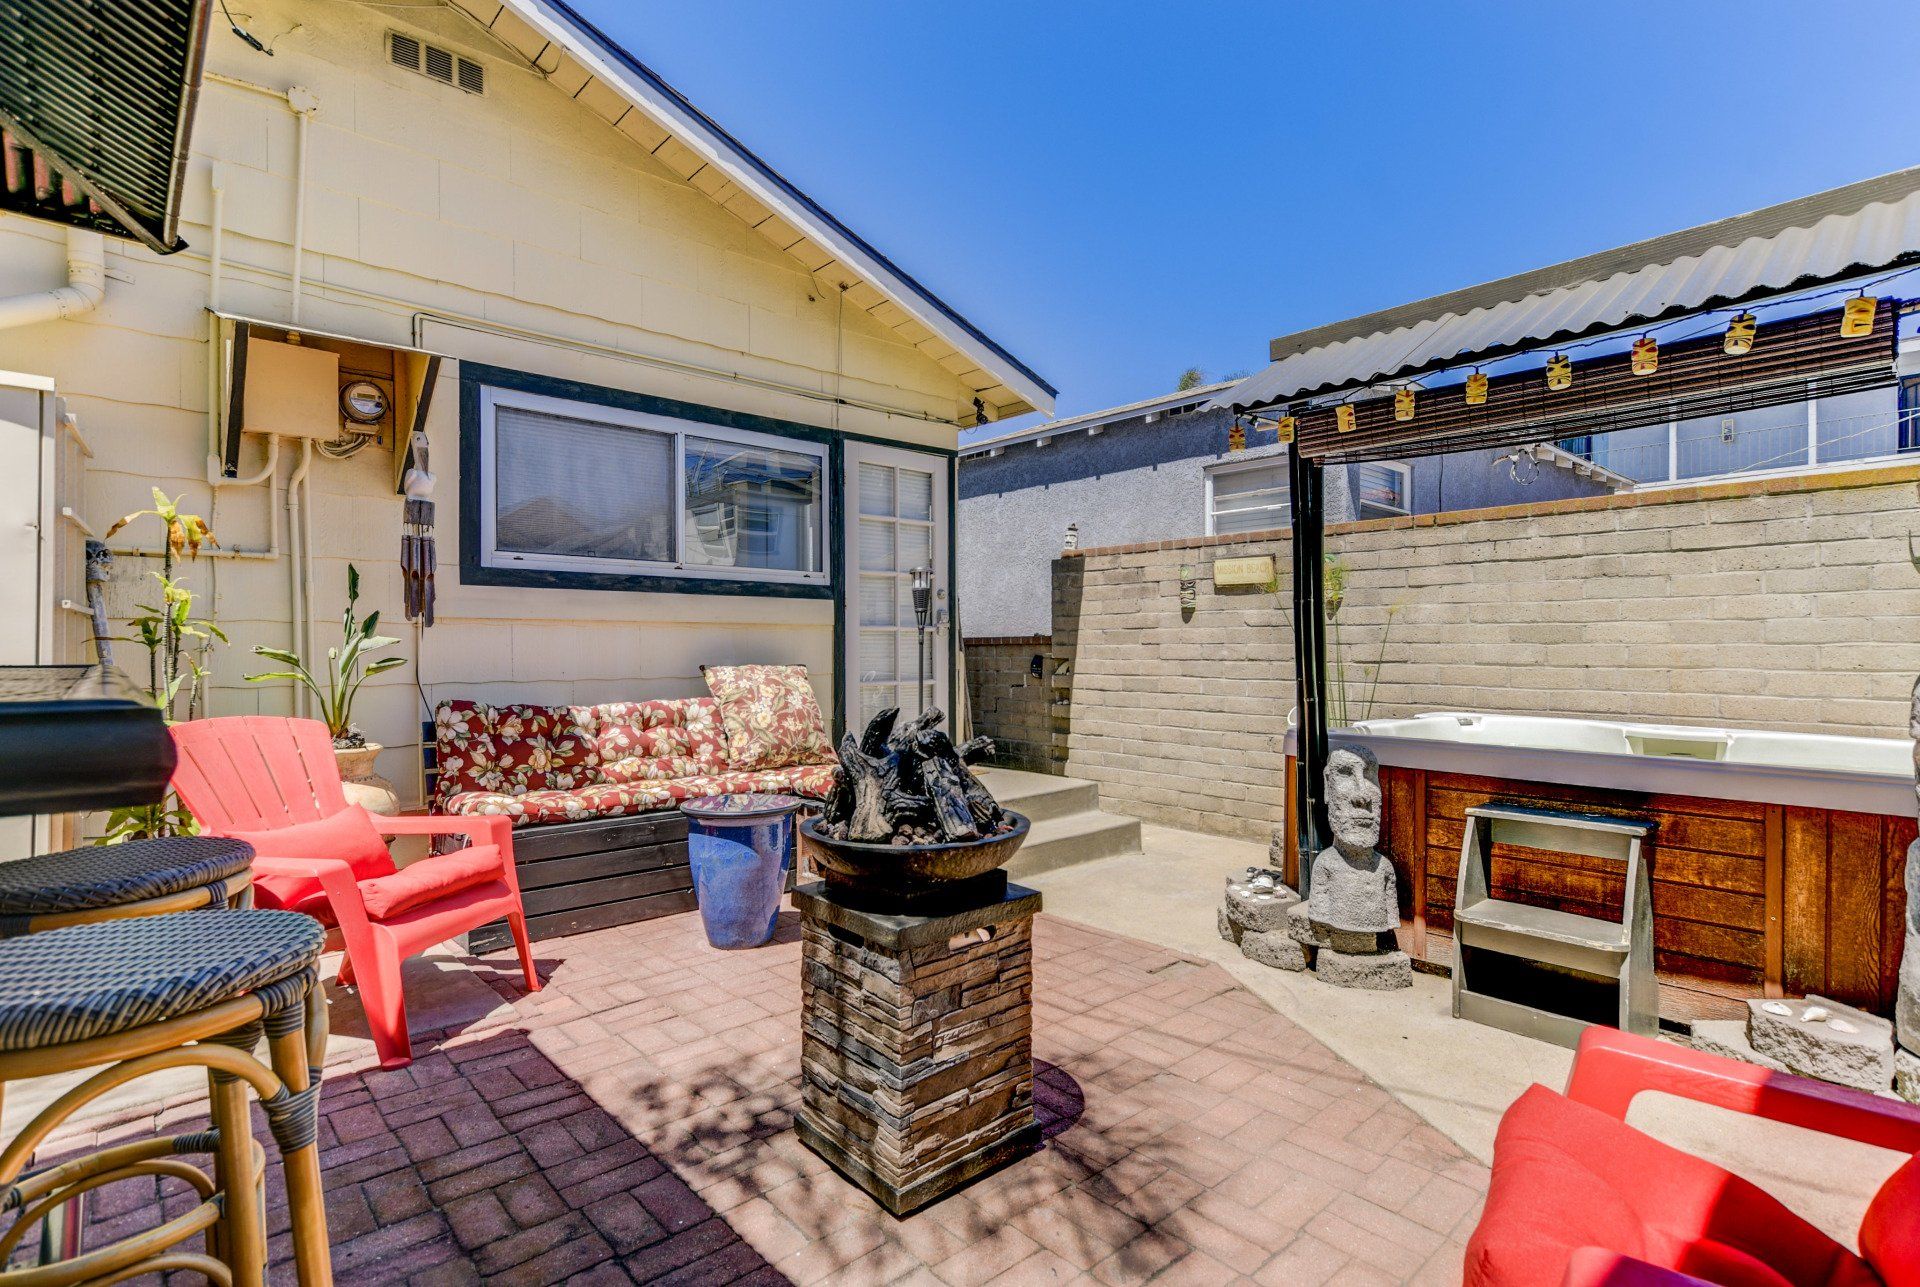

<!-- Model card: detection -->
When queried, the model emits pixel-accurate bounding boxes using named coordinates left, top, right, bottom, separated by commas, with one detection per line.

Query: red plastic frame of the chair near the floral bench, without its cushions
left=173, top=716, right=540, bottom=1068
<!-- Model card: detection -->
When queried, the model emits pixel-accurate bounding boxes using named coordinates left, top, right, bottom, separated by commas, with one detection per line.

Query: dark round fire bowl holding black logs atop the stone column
left=801, top=811, right=1031, bottom=914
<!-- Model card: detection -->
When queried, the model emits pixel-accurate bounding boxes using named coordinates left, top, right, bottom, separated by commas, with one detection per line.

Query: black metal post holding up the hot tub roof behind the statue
left=1286, top=451, right=1329, bottom=893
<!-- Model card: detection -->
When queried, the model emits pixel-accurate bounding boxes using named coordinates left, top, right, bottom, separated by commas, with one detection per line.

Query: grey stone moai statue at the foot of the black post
left=1286, top=747, right=1413, bottom=991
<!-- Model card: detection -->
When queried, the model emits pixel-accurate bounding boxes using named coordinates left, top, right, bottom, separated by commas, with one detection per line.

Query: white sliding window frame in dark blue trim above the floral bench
left=472, top=382, right=833, bottom=588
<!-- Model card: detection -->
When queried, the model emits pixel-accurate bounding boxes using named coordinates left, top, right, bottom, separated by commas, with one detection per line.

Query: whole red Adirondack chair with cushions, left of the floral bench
left=173, top=716, right=540, bottom=1068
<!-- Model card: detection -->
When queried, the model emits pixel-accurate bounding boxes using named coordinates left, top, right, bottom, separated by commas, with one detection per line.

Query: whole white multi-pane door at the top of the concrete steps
left=845, top=442, right=952, bottom=732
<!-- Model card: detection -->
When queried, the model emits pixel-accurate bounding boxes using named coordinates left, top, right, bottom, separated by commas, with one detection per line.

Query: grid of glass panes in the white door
left=856, top=463, right=947, bottom=724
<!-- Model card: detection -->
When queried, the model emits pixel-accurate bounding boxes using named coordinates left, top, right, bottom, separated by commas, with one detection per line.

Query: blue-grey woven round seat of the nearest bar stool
left=0, top=911, right=326, bottom=1053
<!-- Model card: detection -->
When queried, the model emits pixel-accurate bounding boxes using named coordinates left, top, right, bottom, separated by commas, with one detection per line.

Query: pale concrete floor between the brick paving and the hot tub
left=1029, top=824, right=1907, bottom=1247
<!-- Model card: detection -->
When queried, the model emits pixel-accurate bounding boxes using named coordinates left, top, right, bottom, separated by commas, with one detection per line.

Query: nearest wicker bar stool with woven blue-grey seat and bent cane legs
left=0, top=911, right=332, bottom=1287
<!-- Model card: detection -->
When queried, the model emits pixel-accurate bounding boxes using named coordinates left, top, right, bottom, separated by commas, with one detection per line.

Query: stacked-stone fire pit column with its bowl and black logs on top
left=793, top=711, right=1041, bottom=1216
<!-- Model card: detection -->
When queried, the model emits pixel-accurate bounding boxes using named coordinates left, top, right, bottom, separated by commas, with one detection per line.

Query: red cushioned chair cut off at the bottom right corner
left=1467, top=1028, right=1920, bottom=1287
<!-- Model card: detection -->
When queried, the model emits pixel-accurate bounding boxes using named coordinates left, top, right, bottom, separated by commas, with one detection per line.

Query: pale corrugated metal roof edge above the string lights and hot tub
left=1210, top=169, right=1920, bottom=411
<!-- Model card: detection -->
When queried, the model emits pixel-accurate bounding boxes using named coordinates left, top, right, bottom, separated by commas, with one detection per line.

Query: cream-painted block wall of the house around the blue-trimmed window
left=0, top=0, right=972, bottom=797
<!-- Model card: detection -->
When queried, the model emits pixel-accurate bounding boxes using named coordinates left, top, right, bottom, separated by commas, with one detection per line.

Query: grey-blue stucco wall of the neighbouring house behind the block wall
left=960, top=411, right=1607, bottom=636
